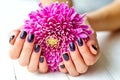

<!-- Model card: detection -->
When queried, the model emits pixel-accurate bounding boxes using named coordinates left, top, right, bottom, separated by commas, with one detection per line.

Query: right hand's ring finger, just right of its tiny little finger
left=62, top=53, right=79, bottom=76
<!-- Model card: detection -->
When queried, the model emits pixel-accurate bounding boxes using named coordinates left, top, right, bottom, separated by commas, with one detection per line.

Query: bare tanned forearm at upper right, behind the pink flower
left=87, top=0, right=120, bottom=31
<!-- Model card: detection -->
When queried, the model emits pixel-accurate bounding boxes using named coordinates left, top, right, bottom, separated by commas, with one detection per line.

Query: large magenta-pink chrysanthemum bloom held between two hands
left=23, top=3, right=92, bottom=71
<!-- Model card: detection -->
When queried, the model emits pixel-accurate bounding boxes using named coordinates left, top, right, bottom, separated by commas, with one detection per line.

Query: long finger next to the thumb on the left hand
left=9, top=31, right=27, bottom=59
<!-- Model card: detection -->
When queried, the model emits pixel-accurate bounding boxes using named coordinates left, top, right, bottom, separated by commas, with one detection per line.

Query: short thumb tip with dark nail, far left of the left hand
left=9, top=30, right=20, bottom=45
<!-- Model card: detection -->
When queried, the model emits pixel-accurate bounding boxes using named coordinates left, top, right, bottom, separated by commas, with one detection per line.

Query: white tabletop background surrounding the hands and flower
left=0, top=0, right=120, bottom=80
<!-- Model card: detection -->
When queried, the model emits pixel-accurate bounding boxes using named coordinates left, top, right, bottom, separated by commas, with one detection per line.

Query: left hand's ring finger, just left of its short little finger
left=28, top=44, right=41, bottom=72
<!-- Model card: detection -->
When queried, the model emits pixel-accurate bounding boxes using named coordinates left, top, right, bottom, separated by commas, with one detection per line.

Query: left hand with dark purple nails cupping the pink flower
left=9, top=29, right=48, bottom=73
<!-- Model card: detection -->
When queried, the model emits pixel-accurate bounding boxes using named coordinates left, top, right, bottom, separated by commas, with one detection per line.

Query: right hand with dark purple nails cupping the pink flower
left=59, top=22, right=101, bottom=76
